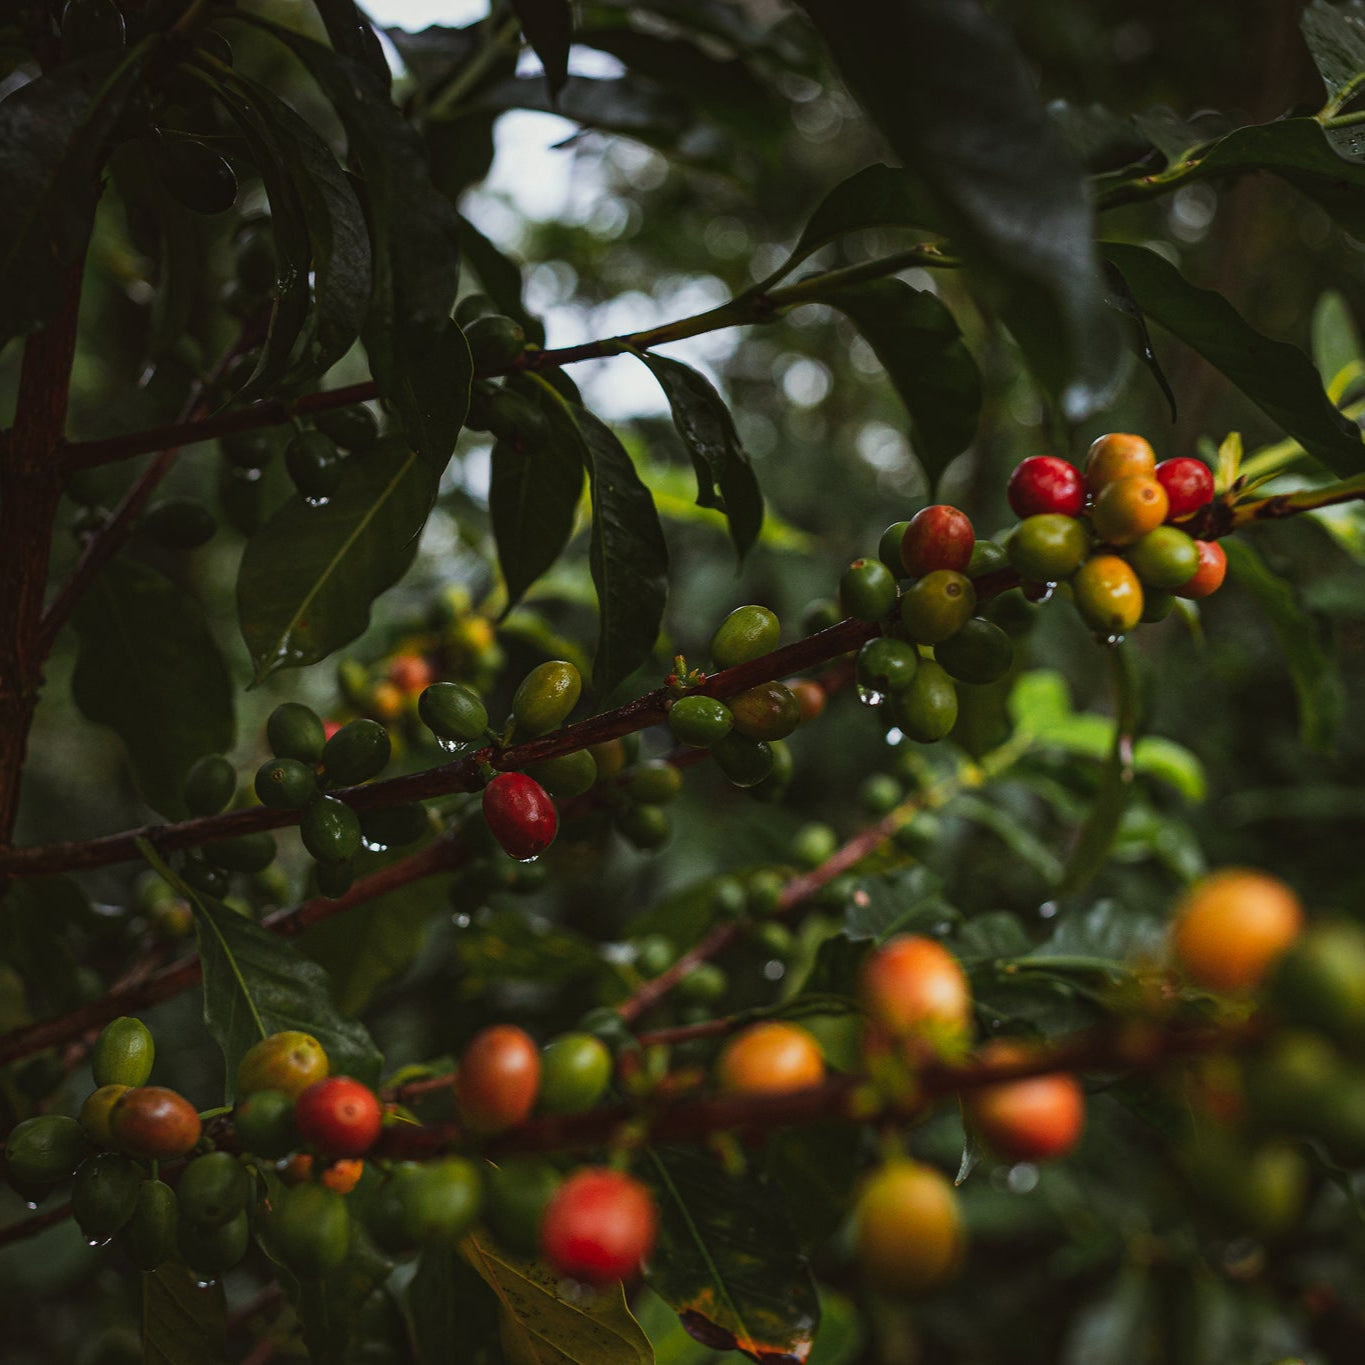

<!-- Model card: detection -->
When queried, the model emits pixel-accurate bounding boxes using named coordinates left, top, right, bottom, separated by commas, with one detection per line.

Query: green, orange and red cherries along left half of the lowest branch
left=5, top=1017, right=658, bottom=1284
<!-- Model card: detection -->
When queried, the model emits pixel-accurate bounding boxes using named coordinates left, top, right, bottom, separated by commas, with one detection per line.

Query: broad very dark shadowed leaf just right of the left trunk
left=71, top=558, right=235, bottom=818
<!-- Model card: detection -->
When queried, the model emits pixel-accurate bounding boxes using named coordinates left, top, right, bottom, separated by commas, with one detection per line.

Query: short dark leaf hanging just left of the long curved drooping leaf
left=489, top=378, right=583, bottom=607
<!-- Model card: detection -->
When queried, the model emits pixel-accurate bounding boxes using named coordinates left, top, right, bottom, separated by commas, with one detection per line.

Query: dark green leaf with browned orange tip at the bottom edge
left=639, top=1147, right=820, bottom=1361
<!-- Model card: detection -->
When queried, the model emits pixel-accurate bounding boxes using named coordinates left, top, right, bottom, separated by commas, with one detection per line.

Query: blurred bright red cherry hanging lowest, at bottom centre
left=541, top=1166, right=659, bottom=1284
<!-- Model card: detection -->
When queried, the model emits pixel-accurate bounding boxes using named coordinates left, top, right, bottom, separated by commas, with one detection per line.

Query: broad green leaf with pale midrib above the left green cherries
left=237, top=437, right=437, bottom=682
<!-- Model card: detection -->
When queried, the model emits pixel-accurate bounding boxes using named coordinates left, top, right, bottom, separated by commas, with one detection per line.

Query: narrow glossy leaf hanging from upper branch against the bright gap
left=639, top=351, right=763, bottom=560
